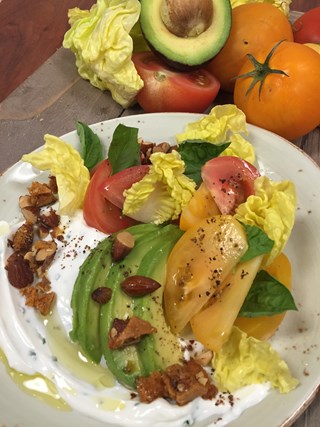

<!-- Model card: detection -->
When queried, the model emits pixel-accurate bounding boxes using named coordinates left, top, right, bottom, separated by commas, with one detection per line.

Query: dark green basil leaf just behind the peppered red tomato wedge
left=177, top=139, right=230, bottom=185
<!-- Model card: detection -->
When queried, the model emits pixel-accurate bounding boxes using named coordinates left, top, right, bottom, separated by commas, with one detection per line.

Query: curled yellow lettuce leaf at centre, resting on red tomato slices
left=123, top=151, right=196, bottom=224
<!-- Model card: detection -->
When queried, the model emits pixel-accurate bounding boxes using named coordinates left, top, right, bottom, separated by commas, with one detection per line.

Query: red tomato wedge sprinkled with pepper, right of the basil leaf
left=201, top=156, right=260, bottom=215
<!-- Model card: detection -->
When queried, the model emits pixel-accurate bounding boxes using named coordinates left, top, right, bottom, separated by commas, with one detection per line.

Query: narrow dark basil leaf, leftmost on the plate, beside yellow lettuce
left=76, top=121, right=104, bottom=171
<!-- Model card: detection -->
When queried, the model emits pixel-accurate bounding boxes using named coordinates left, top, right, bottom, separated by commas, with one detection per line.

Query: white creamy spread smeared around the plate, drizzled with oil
left=0, top=212, right=270, bottom=427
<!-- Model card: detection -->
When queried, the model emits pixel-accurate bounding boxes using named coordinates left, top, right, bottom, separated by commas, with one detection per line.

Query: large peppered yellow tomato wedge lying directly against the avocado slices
left=164, top=215, right=248, bottom=333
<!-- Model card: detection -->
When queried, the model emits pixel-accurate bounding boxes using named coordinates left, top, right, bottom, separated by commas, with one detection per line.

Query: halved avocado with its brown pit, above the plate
left=140, top=0, right=231, bottom=69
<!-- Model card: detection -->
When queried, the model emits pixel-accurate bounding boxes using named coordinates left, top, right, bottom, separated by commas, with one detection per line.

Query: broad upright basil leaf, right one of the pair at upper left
left=108, top=124, right=141, bottom=175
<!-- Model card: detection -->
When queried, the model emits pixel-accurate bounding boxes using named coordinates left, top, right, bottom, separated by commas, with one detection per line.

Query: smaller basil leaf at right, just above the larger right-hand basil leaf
left=239, top=221, right=274, bottom=262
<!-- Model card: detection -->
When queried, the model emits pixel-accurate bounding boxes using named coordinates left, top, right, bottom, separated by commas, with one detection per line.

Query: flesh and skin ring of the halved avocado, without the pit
left=140, top=0, right=231, bottom=72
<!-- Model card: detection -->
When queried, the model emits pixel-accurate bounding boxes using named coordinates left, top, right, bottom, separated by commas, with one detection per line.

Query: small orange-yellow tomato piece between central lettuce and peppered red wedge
left=179, top=183, right=220, bottom=230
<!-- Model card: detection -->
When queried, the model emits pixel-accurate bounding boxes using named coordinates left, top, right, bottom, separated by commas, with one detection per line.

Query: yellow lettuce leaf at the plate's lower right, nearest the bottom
left=212, top=326, right=299, bottom=393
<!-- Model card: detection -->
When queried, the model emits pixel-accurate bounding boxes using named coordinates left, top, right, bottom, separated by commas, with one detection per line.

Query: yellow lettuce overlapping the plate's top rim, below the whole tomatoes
left=176, top=104, right=255, bottom=163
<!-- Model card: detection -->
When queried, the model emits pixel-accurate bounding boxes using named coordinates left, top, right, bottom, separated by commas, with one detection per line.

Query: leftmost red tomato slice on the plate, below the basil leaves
left=83, top=160, right=137, bottom=234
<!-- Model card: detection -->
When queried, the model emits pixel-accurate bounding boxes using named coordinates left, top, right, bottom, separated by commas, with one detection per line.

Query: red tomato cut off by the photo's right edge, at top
left=292, top=6, right=320, bottom=43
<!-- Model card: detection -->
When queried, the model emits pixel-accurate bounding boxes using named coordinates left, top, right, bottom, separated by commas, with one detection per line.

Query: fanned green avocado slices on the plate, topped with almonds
left=70, top=224, right=183, bottom=388
